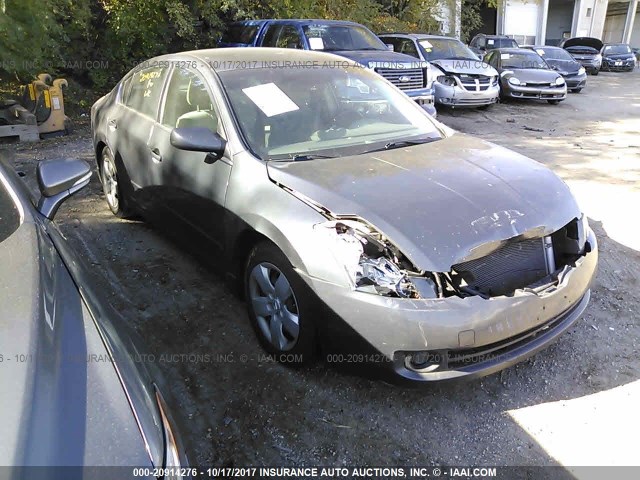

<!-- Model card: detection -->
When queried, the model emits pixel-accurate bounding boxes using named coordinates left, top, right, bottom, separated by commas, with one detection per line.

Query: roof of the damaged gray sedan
left=148, top=47, right=356, bottom=72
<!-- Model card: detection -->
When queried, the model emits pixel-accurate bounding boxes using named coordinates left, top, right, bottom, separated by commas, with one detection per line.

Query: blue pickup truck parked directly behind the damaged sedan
left=218, top=20, right=436, bottom=115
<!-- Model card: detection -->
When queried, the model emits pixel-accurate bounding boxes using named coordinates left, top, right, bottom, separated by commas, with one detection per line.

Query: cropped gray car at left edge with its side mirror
left=0, top=159, right=188, bottom=468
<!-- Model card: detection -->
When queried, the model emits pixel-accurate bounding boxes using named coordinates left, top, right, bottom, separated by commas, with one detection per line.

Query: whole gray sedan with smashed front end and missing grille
left=91, top=48, right=597, bottom=381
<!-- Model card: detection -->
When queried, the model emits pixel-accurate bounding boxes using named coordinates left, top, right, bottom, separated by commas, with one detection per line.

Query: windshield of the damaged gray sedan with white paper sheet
left=219, top=62, right=442, bottom=160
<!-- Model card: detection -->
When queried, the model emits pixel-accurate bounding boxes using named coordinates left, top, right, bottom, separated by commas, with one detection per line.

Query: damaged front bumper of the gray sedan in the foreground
left=299, top=229, right=598, bottom=382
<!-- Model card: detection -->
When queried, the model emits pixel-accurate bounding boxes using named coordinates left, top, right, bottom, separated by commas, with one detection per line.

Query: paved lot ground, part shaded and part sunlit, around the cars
left=5, top=71, right=640, bottom=466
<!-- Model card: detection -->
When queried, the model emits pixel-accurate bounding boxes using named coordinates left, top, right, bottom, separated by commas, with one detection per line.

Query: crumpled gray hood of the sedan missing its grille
left=267, top=134, right=580, bottom=271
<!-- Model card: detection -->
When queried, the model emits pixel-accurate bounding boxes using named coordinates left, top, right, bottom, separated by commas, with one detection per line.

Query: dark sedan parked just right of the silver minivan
left=484, top=48, right=567, bottom=104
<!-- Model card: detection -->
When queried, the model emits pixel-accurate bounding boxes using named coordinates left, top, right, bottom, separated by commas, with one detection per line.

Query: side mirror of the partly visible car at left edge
left=36, top=158, right=91, bottom=220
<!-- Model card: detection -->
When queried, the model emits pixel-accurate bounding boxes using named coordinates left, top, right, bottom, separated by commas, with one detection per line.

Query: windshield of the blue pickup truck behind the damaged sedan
left=303, top=25, right=387, bottom=52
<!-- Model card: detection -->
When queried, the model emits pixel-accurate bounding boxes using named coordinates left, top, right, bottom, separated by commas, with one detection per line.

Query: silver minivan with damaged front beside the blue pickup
left=379, top=33, right=500, bottom=107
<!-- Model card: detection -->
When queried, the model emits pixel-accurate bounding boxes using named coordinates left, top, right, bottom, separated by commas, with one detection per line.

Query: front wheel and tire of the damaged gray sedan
left=244, top=242, right=316, bottom=365
